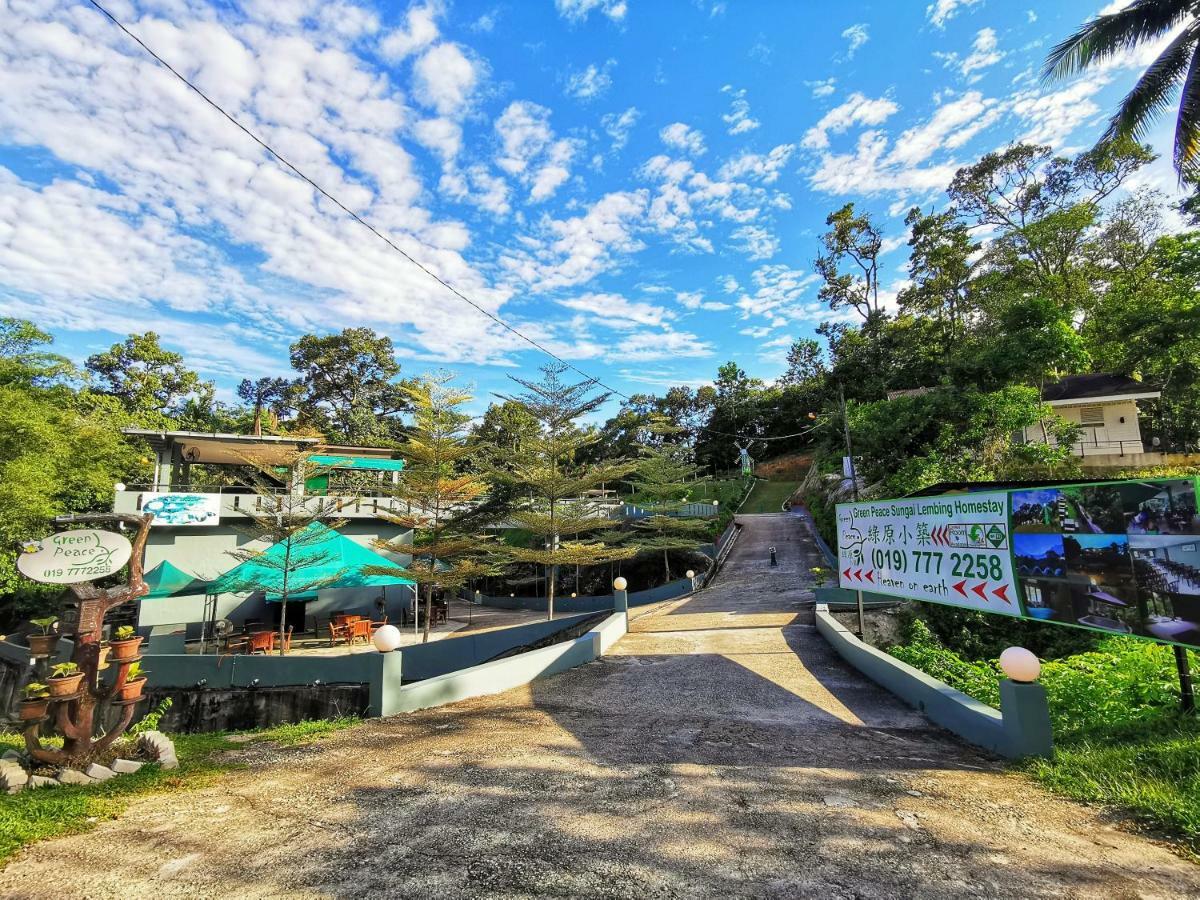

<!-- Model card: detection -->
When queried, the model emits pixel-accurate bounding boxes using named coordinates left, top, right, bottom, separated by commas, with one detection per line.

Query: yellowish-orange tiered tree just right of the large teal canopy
left=376, top=374, right=496, bottom=641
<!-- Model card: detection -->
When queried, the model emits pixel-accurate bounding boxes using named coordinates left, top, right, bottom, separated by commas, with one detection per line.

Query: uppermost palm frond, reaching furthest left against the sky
left=1042, top=0, right=1194, bottom=78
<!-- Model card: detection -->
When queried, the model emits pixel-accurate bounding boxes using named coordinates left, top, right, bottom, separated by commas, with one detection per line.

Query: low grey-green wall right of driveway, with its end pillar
left=816, top=604, right=1052, bottom=758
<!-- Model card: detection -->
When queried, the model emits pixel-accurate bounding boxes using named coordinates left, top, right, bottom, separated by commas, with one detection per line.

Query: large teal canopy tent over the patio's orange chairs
left=209, top=522, right=414, bottom=600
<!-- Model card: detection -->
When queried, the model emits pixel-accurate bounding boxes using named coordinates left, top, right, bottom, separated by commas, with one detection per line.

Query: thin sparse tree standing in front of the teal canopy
left=211, top=454, right=346, bottom=656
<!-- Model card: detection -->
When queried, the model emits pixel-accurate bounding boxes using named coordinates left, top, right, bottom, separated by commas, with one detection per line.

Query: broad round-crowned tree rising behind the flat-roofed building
left=290, top=328, right=408, bottom=444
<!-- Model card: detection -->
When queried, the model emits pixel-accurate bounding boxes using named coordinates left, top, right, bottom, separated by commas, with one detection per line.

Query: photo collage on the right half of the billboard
left=1012, top=479, right=1200, bottom=644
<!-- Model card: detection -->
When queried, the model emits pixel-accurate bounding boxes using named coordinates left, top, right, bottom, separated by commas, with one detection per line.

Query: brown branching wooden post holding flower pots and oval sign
left=25, top=512, right=154, bottom=766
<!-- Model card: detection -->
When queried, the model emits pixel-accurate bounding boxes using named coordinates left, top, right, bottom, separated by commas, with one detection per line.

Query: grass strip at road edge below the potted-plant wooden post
left=0, top=718, right=359, bottom=866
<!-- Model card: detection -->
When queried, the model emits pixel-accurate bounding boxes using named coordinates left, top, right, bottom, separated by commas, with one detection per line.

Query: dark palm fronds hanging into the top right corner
left=1043, top=0, right=1200, bottom=179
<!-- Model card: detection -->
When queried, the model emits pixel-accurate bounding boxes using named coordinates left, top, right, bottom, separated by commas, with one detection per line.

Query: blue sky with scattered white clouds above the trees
left=0, top=0, right=1174, bottom=415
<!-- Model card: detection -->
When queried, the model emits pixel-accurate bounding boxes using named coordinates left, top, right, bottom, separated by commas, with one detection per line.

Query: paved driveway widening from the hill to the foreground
left=0, top=516, right=1200, bottom=900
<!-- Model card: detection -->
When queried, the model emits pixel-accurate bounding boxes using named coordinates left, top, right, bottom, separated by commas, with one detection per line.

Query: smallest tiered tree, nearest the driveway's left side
left=625, top=444, right=709, bottom=582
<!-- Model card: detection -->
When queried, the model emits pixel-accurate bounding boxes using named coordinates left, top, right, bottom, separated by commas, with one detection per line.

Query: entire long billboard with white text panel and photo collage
left=838, top=478, right=1200, bottom=648
